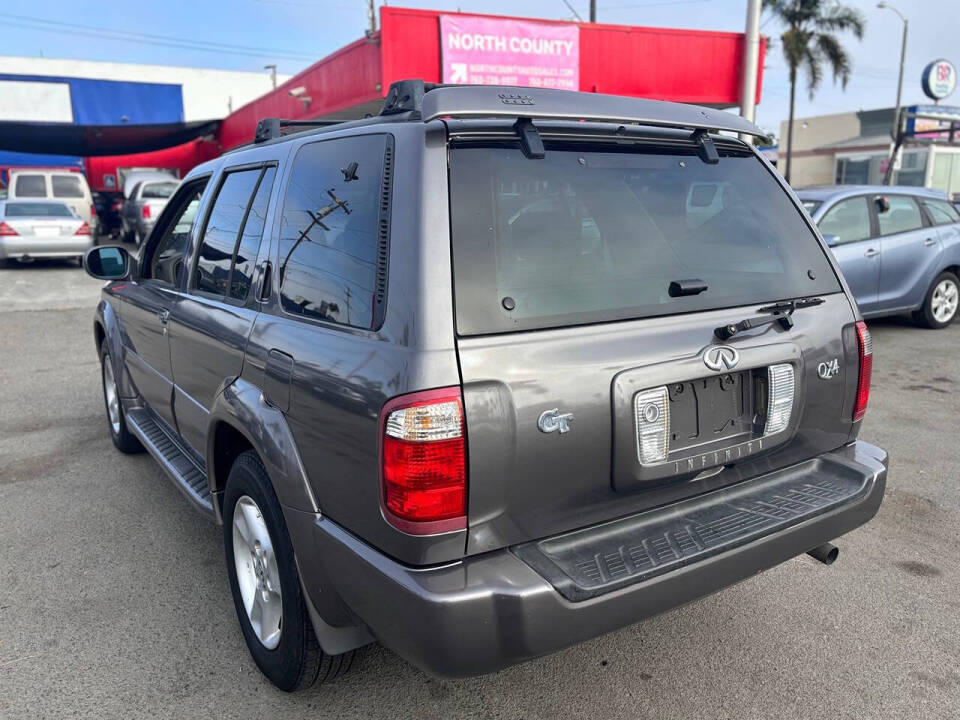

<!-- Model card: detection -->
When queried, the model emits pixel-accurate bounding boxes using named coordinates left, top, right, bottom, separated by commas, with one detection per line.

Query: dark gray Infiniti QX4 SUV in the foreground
left=86, top=81, right=887, bottom=690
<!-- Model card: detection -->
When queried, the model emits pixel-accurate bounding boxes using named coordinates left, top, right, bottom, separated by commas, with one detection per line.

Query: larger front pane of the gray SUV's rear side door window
left=193, top=168, right=262, bottom=295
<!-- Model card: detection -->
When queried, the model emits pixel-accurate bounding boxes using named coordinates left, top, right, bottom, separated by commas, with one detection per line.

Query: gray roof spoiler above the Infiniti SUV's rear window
left=381, top=80, right=767, bottom=138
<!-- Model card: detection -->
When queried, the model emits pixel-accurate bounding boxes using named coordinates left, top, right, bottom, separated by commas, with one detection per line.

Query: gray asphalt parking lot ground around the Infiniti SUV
left=0, top=262, right=960, bottom=718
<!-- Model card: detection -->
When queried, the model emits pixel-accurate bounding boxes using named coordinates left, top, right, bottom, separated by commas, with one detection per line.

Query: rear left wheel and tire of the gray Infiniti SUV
left=223, top=451, right=356, bottom=692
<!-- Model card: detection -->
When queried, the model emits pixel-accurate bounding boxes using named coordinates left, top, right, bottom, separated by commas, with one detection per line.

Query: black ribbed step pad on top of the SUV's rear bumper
left=513, top=460, right=868, bottom=601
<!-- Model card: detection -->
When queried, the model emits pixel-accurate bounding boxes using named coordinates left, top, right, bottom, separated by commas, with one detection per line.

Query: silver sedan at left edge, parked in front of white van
left=0, top=200, right=93, bottom=267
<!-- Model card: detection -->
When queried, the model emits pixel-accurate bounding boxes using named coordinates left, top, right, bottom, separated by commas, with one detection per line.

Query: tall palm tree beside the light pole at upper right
left=763, top=0, right=867, bottom=182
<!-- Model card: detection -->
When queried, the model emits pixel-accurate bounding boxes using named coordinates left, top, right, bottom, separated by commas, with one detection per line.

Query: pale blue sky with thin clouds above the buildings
left=0, top=0, right=960, bottom=132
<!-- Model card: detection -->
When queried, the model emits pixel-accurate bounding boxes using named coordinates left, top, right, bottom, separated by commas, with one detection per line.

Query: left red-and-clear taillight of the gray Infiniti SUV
left=380, top=387, right=467, bottom=535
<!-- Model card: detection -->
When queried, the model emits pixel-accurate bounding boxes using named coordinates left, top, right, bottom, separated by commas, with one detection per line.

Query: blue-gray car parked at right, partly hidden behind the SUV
left=797, top=185, right=960, bottom=328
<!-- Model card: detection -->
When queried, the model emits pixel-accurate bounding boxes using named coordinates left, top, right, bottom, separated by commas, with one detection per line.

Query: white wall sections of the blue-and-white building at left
left=0, top=56, right=291, bottom=122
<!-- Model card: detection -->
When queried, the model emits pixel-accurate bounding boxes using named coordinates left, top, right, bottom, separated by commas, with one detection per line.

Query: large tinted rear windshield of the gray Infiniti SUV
left=450, top=146, right=840, bottom=335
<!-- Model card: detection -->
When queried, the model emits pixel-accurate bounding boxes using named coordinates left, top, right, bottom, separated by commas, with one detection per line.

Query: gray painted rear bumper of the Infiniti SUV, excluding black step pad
left=312, top=442, right=887, bottom=677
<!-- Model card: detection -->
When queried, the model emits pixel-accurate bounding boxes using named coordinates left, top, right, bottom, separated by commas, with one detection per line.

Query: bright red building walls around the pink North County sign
left=87, top=6, right=766, bottom=189
